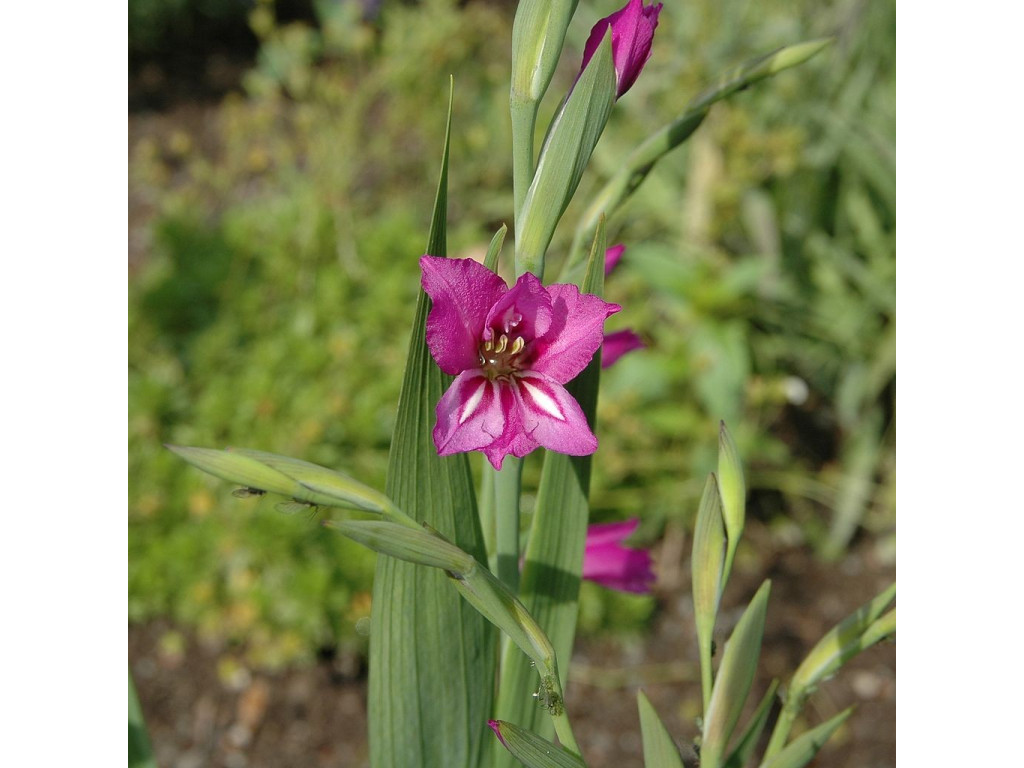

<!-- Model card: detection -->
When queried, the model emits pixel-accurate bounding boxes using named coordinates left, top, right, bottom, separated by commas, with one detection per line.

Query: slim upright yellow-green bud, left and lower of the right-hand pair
left=690, top=474, right=725, bottom=712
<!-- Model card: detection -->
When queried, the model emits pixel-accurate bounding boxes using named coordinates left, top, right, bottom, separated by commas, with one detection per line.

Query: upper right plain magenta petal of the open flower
left=530, top=284, right=622, bottom=384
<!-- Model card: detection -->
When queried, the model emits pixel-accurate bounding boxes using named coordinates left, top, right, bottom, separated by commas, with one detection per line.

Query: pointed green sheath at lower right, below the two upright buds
left=700, top=582, right=771, bottom=768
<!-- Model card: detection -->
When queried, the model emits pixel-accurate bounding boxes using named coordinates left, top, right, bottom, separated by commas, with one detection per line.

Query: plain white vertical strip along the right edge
left=897, top=2, right=1024, bottom=765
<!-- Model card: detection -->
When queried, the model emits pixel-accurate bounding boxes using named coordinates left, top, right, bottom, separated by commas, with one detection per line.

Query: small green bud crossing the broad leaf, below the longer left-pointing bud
left=324, top=520, right=476, bottom=575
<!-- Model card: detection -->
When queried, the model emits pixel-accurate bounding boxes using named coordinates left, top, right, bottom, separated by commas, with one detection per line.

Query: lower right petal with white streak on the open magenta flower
left=513, top=371, right=597, bottom=456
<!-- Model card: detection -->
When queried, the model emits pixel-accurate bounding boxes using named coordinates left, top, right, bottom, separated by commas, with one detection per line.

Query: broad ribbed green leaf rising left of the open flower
left=369, top=78, right=496, bottom=768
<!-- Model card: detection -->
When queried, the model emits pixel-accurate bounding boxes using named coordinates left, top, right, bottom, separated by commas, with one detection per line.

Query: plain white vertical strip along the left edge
left=0, top=2, right=128, bottom=765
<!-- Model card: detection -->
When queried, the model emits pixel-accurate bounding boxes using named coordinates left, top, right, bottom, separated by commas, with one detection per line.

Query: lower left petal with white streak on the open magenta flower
left=433, top=371, right=514, bottom=456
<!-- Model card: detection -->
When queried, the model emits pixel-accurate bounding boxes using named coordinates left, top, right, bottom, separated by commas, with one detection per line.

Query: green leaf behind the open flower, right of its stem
left=497, top=219, right=606, bottom=765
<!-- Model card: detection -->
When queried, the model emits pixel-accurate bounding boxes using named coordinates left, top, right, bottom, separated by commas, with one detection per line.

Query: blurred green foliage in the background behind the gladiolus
left=129, top=0, right=895, bottom=667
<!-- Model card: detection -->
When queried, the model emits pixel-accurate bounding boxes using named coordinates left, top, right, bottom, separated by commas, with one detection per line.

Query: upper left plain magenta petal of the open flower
left=420, top=256, right=508, bottom=376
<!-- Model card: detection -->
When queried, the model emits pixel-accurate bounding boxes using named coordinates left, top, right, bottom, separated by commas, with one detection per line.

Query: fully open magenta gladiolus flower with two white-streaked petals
left=420, top=256, right=622, bottom=469
